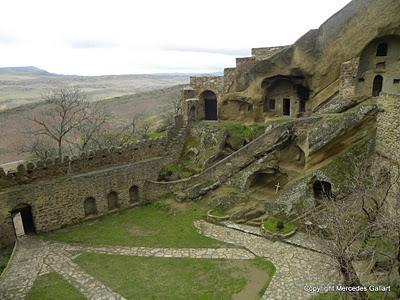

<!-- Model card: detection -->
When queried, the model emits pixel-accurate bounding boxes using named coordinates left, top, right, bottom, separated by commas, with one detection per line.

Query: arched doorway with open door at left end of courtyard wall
left=11, top=204, right=36, bottom=236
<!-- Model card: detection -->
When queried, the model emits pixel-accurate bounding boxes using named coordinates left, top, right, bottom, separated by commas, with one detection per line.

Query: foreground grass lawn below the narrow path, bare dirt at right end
left=75, top=253, right=275, bottom=300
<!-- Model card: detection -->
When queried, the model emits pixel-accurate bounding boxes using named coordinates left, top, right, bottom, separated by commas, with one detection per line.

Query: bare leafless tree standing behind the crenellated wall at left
left=31, top=87, right=88, bottom=158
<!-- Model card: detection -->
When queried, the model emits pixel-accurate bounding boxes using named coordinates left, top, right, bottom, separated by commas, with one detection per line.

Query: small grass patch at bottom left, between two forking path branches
left=26, top=273, right=85, bottom=300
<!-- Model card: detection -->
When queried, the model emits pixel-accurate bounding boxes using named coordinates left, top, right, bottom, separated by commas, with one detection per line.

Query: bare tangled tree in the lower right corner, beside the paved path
left=310, top=156, right=400, bottom=299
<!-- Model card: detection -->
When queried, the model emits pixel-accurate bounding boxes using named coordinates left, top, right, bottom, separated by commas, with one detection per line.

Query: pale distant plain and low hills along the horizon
left=0, top=67, right=189, bottom=111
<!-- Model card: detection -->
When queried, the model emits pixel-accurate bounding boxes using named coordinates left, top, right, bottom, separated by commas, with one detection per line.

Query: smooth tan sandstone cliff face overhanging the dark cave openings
left=222, top=0, right=400, bottom=121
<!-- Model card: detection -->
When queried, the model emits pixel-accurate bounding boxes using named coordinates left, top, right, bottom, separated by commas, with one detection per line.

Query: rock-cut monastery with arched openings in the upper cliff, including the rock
left=182, top=0, right=400, bottom=122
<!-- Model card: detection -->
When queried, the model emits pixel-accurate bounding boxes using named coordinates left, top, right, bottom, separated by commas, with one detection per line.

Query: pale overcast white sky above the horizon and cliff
left=0, top=0, right=350, bottom=75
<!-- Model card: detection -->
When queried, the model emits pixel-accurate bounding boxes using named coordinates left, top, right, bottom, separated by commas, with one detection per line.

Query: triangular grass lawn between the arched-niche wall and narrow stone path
left=45, top=200, right=227, bottom=248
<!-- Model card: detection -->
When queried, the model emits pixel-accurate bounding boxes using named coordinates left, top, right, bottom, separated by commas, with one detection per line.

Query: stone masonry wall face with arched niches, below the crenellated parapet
left=0, top=158, right=167, bottom=247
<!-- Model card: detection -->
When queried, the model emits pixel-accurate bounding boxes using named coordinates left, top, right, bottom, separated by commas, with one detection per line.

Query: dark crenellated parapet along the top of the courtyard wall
left=0, top=116, right=186, bottom=190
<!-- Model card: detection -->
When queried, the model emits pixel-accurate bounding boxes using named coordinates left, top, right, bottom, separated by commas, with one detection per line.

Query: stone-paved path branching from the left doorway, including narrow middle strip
left=0, top=236, right=255, bottom=300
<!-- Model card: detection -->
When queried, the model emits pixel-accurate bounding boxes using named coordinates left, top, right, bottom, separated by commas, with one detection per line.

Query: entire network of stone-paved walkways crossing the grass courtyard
left=0, top=221, right=337, bottom=300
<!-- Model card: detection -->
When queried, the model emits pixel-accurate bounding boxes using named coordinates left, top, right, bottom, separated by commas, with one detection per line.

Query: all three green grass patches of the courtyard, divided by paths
left=28, top=199, right=275, bottom=300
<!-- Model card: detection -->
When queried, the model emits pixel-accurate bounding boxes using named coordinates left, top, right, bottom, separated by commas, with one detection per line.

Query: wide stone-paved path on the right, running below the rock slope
left=195, top=221, right=339, bottom=300
